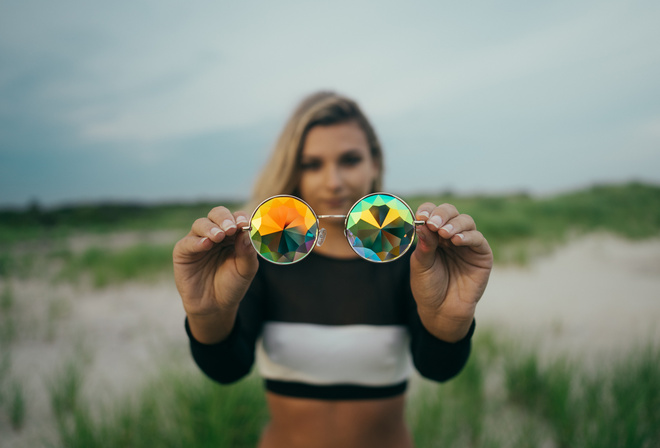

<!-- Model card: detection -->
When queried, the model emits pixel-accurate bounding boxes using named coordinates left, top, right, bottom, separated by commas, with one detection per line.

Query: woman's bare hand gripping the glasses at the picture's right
left=410, top=202, right=493, bottom=342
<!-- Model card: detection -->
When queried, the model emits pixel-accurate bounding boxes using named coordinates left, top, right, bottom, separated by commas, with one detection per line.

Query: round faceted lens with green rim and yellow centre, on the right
left=346, top=193, right=415, bottom=263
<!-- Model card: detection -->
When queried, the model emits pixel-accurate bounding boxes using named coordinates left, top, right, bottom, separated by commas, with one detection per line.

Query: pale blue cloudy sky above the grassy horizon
left=0, top=0, right=660, bottom=207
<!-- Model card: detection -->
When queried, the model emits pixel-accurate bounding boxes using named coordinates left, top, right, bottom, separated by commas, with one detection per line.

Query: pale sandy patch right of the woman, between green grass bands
left=477, top=235, right=660, bottom=356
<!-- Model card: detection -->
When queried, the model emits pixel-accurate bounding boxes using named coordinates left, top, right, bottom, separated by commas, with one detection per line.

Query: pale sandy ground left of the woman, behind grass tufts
left=0, top=280, right=195, bottom=448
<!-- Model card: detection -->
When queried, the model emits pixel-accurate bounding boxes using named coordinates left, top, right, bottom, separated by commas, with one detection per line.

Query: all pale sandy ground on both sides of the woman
left=0, top=235, right=660, bottom=447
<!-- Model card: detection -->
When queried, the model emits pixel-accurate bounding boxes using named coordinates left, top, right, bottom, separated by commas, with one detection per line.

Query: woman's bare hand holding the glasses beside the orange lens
left=172, top=207, right=259, bottom=339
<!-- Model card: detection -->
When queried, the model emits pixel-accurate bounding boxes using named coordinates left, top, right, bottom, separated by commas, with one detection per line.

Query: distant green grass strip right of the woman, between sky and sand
left=409, top=183, right=660, bottom=264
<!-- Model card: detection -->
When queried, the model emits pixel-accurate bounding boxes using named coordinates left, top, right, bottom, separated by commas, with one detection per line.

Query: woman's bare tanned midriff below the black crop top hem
left=259, top=392, right=413, bottom=448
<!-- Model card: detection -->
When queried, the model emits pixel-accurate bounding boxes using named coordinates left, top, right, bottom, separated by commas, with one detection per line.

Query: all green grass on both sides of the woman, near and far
left=0, top=183, right=660, bottom=448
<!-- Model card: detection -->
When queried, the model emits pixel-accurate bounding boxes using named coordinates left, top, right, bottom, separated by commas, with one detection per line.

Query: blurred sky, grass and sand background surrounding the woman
left=0, top=0, right=660, bottom=448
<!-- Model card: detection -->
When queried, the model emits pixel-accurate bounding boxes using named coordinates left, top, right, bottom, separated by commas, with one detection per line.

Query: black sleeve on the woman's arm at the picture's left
left=185, top=264, right=264, bottom=384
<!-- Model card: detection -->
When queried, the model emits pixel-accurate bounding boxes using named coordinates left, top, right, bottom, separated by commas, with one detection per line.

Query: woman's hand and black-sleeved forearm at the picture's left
left=172, top=207, right=259, bottom=381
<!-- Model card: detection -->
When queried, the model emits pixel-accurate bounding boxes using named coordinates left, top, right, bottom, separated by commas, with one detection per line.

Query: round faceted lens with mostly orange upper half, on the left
left=250, top=196, right=318, bottom=264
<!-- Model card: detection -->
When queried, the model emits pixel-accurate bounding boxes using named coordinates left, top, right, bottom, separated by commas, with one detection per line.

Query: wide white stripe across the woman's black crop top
left=256, top=322, right=412, bottom=386
